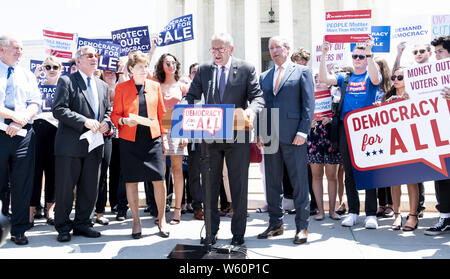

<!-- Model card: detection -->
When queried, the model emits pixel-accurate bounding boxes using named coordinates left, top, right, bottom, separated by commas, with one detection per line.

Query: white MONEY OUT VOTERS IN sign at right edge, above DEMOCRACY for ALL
left=403, top=58, right=450, bottom=98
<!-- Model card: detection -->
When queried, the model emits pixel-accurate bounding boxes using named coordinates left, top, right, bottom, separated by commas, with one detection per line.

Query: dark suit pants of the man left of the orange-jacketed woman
left=55, top=150, right=103, bottom=233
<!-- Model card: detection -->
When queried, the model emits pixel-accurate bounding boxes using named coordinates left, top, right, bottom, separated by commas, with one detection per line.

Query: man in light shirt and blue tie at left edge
left=0, top=36, right=42, bottom=245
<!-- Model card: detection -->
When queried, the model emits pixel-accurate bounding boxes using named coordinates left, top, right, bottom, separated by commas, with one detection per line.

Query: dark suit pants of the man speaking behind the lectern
left=207, top=143, right=250, bottom=237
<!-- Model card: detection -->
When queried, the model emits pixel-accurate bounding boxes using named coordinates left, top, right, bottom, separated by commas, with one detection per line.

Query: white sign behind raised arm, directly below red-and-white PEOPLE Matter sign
left=312, top=43, right=350, bottom=73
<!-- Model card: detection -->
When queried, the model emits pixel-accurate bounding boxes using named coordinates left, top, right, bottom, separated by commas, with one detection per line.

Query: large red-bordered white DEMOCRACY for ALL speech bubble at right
left=345, top=92, right=450, bottom=176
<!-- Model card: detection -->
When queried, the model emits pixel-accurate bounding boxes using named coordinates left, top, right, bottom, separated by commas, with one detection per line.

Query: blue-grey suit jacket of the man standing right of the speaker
left=259, top=63, right=315, bottom=144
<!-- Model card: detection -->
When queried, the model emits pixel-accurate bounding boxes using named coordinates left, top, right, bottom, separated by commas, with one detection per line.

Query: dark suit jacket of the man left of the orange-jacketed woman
left=52, top=72, right=112, bottom=157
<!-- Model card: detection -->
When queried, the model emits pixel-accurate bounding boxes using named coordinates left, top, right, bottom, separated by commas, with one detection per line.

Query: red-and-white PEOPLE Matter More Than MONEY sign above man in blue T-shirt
left=325, top=10, right=372, bottom=43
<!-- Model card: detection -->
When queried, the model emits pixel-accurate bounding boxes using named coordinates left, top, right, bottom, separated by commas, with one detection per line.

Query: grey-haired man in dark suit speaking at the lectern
left=183, top=34, right=264, bottom=246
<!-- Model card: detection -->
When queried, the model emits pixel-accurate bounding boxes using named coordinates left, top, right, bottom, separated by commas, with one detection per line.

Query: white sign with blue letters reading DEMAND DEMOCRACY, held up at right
left=391, top=16, right=431, bottom=46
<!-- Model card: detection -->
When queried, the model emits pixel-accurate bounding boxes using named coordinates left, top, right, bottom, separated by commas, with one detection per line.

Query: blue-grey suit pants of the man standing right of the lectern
left=264, top=143, right=310, bottom=231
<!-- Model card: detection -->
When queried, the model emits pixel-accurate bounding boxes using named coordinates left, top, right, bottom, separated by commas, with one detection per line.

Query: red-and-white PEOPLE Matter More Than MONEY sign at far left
left=43, top=29, right=78, bottom=59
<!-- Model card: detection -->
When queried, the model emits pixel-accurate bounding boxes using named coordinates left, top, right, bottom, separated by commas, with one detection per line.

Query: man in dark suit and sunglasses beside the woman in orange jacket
left=53, top=47, right=112, bottom=242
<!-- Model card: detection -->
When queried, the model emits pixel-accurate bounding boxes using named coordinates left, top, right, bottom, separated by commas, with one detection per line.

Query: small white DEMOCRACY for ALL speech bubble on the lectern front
left=181, top=107, right=223, bottom=136
